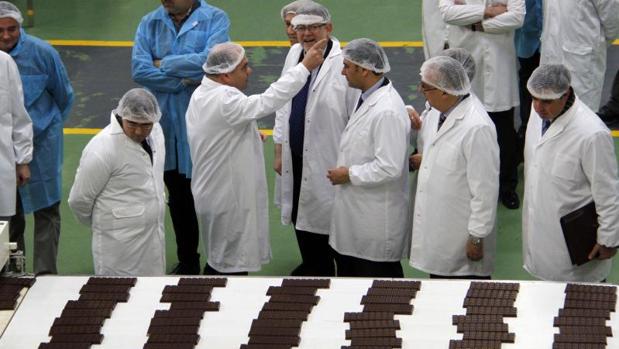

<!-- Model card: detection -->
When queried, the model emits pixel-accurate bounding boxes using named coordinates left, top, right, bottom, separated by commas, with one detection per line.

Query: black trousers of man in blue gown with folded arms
left=163, top=170, right=200, bottom=274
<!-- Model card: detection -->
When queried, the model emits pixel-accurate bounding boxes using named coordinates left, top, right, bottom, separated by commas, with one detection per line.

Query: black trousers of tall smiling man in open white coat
left=291, top=154, right=335, bottom=276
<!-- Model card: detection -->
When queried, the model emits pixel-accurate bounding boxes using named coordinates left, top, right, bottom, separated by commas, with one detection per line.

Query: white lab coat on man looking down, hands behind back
left=69, top=114, right=166, bottom=276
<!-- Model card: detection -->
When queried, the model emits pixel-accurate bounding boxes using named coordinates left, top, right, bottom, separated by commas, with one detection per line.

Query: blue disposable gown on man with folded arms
left=131, top=0, right=230, bottom=174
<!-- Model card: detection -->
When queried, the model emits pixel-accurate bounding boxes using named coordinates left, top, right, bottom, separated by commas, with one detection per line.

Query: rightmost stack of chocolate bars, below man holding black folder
left=552, top=284, right=617, bottom=349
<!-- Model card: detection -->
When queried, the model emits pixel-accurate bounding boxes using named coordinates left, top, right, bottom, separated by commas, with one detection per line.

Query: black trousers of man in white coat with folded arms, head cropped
left=488, top=108, right=518, bottom=193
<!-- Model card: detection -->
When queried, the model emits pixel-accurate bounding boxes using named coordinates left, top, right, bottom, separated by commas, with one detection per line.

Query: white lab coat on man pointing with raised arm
left=186, top=64, right=309, bottom=273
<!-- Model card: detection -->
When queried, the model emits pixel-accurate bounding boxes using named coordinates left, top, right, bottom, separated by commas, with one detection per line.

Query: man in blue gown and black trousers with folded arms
left=131, top=0, right=230, bottom=274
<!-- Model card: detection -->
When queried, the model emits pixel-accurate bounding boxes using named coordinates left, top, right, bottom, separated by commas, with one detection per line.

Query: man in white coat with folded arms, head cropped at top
left=439, top=0, right=525, bottom=209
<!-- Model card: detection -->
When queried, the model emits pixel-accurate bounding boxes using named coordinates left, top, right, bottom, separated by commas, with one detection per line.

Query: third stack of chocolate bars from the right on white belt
left=342, top=280, right=421, bottom=349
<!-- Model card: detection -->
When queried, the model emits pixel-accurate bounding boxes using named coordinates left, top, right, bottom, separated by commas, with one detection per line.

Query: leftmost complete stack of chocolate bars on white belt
left=39, top=277, right=137, bottom=349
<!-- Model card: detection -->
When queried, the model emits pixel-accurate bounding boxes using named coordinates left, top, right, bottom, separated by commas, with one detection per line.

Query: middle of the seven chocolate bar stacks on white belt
left=241, top=279, right=331, bottom=349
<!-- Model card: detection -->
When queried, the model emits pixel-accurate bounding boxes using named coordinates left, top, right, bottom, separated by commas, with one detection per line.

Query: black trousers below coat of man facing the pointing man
left=333, top=251, right=404, bottom=278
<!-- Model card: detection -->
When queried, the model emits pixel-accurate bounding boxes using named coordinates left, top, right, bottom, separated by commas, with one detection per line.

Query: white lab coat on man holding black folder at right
left=522, top=97, right=619, bottom=282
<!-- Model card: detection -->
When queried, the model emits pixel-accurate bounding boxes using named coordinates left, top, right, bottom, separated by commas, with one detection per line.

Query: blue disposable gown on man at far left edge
left=9, top=29, right=73, bottom=213
